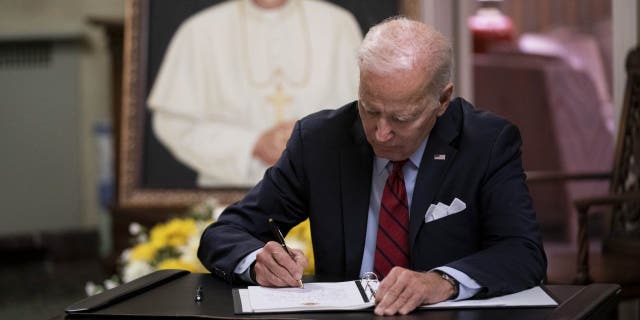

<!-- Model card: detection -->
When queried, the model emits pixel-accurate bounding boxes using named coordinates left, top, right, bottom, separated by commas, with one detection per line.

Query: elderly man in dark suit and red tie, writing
left=198, top=18, right=546, bottom=315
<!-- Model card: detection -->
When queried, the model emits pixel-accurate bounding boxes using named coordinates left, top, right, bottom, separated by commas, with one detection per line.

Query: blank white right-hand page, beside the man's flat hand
left=420, top=287, right=558, bottom=309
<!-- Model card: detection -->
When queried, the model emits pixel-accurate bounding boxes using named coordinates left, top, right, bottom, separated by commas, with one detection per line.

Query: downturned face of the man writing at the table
left=358, top=71, right=452, bottom=161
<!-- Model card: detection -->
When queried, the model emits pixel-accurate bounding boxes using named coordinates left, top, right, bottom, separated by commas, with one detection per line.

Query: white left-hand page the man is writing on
left=243, top=281, right=373, bottom=312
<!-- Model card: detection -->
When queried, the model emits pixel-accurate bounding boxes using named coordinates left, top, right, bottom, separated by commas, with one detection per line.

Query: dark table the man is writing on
left=52, top=274, right=620, bottom=320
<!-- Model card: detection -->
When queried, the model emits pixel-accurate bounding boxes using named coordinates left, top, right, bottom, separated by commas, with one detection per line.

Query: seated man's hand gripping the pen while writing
left=253, top=241, right=309, bottom=287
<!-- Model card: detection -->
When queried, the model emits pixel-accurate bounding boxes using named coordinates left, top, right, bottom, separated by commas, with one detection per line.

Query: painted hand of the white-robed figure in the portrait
left=253, top=120, right=295, bottom=165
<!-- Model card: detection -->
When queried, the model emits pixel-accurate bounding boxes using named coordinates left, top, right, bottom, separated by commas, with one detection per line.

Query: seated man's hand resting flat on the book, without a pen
left=374, top=267, right=454, bottom=316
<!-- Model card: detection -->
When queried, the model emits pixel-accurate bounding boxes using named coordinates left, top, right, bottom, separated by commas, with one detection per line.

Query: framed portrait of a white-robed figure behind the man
left=117, top=0, right=419, bottom=208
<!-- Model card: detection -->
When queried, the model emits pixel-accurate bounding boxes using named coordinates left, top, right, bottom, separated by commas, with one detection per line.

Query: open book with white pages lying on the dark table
left=233, top=280, right=558, bottom=314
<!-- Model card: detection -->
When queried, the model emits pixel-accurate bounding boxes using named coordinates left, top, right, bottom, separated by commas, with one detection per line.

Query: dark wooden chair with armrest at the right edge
left=527, top=47, right=640, bottom=299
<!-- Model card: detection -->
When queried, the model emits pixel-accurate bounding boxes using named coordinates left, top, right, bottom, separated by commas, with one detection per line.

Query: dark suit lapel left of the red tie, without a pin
left=340, top=117, right=373, bottom=279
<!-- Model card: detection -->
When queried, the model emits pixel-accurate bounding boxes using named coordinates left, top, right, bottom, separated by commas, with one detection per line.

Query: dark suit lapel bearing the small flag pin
left=409, top=99, right=462, bottom=250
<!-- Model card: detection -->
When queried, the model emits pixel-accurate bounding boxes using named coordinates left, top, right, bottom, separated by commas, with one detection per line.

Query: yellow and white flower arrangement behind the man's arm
left=85, top=199, right=314, bottom=295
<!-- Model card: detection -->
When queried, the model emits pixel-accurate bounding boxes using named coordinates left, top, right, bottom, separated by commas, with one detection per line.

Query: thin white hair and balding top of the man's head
left=358, top=17, right=453, bottom=94
